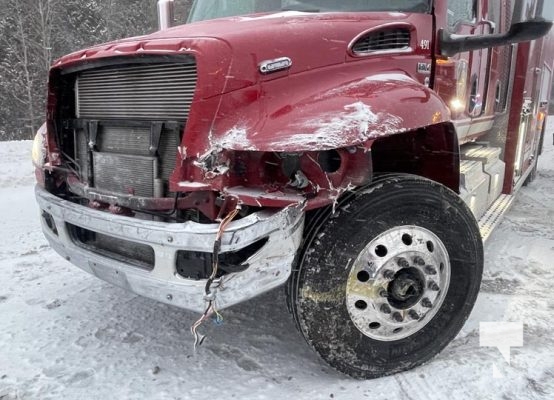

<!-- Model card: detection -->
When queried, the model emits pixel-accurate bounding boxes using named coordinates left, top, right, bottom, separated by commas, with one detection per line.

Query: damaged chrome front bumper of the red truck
left=35, top=186, right=304, bottom=312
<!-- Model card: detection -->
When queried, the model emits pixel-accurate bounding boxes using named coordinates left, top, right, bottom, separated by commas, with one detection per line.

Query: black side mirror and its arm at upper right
left=439, top=0, right=554, bottom=57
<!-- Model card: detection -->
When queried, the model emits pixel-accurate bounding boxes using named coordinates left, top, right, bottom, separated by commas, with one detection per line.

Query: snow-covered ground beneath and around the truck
left=0, top=125, right=554, bottom=400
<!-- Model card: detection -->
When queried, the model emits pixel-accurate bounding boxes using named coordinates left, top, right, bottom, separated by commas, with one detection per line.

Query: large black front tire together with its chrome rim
left=287, top=175, right=483, bottom=379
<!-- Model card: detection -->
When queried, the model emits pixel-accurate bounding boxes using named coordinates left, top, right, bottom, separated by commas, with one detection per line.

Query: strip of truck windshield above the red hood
left=189, top=0, right=431, bottom=22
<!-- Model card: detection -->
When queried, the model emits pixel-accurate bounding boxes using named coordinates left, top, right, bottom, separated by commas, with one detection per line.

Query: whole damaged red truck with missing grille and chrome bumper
left=33, top=0, right=554, bottom=378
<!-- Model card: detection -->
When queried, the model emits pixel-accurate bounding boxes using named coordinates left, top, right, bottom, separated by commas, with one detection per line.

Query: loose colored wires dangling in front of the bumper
left=190, top=206, right=240, bottom=350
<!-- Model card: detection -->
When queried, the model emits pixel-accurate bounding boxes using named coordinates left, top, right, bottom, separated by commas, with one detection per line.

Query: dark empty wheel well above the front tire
left=371, top=123, right=460, bottom=193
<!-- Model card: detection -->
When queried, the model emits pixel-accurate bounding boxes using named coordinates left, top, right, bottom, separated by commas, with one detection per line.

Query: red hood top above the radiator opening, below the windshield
left=54, top=11, right=410, bottom=97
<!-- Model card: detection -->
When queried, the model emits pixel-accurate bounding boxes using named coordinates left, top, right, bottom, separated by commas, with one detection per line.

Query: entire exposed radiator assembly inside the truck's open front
left=63, top=58, right=197, bottom=197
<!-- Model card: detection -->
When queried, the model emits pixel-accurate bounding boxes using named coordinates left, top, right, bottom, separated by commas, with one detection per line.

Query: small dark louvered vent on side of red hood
left=352, top=28, right=410, bottom=55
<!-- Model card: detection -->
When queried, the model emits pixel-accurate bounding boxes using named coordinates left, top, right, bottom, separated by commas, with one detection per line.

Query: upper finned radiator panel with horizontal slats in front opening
left=75, top=63, right=197, bottom=121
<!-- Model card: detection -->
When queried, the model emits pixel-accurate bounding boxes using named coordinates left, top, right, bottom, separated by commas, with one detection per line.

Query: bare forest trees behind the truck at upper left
left=0, top=0, right=192, bottom=141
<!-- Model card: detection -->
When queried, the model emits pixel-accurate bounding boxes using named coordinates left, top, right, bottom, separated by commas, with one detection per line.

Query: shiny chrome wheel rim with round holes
left=346, top=225, right=451, bottom=341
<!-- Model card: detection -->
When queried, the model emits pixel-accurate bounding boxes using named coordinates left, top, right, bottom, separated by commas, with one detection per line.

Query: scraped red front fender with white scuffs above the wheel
left=205, top=71, right=450, bottom=152
